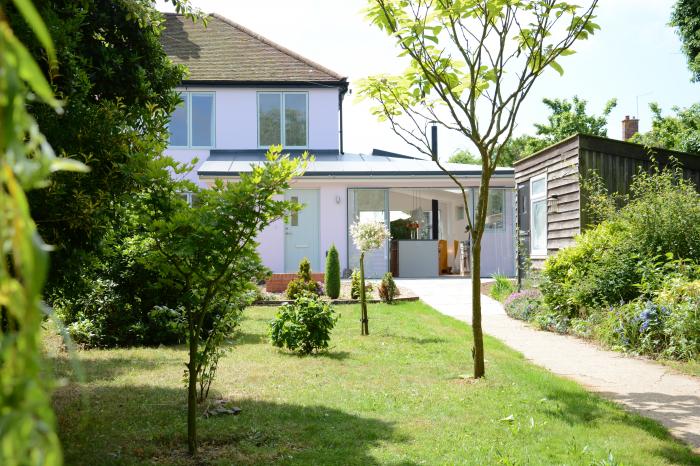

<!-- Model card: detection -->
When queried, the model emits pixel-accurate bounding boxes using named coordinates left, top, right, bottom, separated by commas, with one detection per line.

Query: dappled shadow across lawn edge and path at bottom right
left=541, top=390, right=700, bottom=465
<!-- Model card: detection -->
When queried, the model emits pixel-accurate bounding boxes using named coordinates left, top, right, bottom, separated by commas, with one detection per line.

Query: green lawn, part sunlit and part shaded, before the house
left=49, top=303, right=700, bottom=465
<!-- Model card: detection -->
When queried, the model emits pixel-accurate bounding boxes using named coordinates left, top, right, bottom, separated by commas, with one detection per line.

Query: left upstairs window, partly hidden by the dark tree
left=168, top=92, right=216, bottom=148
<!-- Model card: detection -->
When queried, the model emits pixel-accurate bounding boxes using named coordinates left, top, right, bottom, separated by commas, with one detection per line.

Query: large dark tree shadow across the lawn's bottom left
left=55, top=386, right=410, bottom=465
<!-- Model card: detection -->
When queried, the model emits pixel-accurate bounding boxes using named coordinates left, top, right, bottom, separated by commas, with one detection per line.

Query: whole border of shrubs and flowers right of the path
left=492, top=166, right=700, bottom=374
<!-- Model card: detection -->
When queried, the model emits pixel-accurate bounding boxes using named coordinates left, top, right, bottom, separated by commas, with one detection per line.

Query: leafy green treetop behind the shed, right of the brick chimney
left=630, top=103, right=700, bottom=155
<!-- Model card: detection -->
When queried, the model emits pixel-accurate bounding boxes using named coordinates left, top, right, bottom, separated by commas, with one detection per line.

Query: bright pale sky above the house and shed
left=158, top=0, right=700, bottom=158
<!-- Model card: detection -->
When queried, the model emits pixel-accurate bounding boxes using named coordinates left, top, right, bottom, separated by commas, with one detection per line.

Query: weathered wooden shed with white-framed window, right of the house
left=514, top=134, right=700, bottom=268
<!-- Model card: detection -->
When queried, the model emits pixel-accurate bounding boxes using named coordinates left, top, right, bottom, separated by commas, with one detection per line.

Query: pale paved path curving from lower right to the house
left=397, top=278, right=700, bottom=451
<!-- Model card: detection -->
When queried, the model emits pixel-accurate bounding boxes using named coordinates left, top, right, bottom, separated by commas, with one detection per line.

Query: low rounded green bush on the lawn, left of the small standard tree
left=270, top=294, right=338, bottom=355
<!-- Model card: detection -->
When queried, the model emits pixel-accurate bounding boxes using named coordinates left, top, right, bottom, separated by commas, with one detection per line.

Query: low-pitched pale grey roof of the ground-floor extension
left=197, top=150, right=513, bottom=178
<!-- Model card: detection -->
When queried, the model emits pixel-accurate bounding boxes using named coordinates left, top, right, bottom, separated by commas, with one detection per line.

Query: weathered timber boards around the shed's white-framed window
left=515, top=136, right=581, bottom=268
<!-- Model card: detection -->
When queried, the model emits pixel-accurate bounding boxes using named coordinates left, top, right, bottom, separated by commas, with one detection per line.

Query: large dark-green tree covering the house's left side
left=5, top=0, right=198, bottom=294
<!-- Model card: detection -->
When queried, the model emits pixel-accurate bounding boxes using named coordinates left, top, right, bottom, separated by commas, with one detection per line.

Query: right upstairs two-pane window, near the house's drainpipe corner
left=258, top=92, right=309, bottom=149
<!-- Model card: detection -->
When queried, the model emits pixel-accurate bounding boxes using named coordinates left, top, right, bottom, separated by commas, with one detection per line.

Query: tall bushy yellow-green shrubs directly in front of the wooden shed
left=541, top=164, right=700, bottom=318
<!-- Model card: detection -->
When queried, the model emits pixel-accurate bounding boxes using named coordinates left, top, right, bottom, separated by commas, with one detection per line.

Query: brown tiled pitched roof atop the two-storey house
left=161, top=13, right=347, bottom=85
